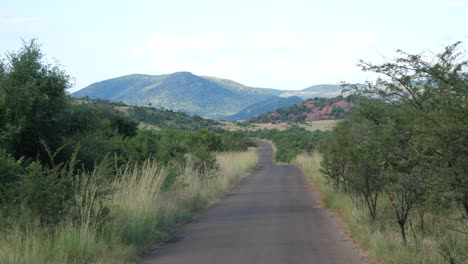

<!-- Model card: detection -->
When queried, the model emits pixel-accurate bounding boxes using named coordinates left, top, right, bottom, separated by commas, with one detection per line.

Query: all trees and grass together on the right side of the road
left=293, top=43, right=468, bottom=263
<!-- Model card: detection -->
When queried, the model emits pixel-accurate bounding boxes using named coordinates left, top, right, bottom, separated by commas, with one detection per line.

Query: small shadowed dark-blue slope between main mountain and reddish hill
left=223, top=96, right=304, bottom=121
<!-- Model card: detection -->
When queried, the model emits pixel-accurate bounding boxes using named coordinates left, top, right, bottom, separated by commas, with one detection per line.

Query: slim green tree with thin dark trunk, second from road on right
left=383, top=103, right=439, bottom=244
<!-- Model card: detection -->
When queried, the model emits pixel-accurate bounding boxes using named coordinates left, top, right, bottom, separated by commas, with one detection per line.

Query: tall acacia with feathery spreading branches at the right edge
left=345, top=42, right=468, bottom=217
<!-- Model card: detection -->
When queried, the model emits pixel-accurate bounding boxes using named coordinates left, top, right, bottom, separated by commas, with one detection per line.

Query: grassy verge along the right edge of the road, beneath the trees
left=292, top=154, right=468, bottom=264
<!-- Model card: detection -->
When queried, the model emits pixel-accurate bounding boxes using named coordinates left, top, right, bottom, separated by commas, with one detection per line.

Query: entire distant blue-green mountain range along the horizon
left=71, top=72, right=356, bottom=120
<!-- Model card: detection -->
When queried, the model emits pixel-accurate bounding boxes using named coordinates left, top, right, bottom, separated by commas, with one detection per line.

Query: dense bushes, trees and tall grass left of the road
left=0, top=41, right=257, bottom=263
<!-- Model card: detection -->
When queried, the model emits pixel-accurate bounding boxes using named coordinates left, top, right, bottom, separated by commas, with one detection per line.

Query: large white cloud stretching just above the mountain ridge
left=126, top=33, right=374, bottom=89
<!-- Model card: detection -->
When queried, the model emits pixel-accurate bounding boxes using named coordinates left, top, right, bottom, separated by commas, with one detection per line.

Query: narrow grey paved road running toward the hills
left=142, top=142, right=365, bottom=264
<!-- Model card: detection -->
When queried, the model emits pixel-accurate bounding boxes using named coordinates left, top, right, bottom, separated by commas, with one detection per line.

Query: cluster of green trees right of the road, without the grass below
left=322, top=43, right=468, bottom=242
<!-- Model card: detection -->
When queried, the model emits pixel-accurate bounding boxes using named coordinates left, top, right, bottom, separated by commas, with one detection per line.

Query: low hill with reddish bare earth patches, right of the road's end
left=249, top=96, right=355, bottom=124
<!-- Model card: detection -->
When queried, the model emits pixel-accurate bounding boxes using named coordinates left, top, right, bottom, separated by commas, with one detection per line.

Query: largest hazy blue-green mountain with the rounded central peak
left=71, top=72, right=276, bottom=118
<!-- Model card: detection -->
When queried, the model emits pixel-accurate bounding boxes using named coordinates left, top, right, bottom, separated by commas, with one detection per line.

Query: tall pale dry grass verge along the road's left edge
left=0, top=150, right=258, bottom=263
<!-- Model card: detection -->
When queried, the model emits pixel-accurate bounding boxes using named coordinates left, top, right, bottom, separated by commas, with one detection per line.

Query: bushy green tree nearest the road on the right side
left=321, top=98, right=387, bottom=221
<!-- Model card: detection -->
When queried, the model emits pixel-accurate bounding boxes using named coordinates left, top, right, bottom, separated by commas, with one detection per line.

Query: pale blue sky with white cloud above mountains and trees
left=0, top=0, right=468, bottom=91
